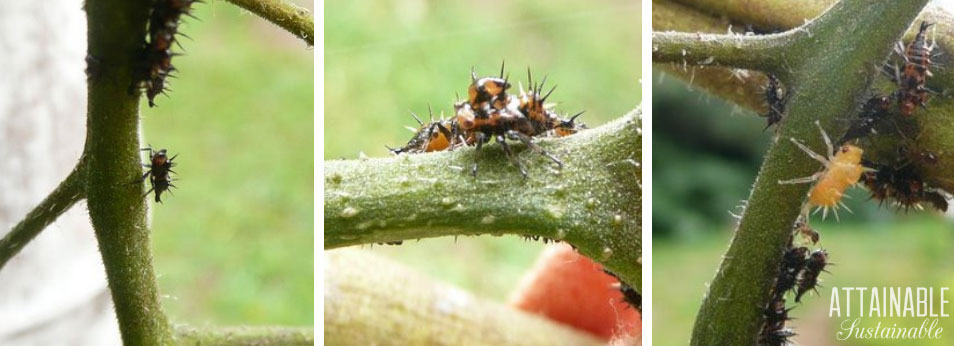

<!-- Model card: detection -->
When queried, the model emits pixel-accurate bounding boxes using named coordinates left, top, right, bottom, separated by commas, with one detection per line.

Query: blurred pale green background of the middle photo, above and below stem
left=324, top=0, right=641, bottom=299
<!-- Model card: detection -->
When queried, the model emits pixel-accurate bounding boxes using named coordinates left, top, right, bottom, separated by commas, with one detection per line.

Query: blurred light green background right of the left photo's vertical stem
left=142, top=1, right=314, bottom=326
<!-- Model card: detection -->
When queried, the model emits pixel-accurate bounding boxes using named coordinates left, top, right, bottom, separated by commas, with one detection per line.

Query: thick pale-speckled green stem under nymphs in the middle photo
left=324, top=112, right=641, bottom=287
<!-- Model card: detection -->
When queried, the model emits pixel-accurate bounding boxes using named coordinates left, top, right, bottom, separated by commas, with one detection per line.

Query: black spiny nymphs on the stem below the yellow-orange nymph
left=758, top=220, right=829, bottom=345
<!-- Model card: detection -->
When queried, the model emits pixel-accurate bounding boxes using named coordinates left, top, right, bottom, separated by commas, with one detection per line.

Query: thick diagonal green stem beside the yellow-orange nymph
left=692, top=0, right=927, bottom=345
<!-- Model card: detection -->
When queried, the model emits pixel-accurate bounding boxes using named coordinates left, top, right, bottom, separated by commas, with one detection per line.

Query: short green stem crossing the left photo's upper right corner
left=226, top=0, right=315, bottom=46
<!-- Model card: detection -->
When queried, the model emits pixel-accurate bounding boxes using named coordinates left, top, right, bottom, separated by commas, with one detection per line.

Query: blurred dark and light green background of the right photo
left=652, top=71, right=954, bottom=345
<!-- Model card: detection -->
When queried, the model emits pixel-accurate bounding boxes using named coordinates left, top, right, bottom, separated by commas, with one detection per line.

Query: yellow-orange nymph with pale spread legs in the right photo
left=778, top=121, right=866, bottom=218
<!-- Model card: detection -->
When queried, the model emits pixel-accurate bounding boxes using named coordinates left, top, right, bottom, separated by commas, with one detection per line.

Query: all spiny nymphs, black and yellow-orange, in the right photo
left=759, top=22, right=948, bottom=345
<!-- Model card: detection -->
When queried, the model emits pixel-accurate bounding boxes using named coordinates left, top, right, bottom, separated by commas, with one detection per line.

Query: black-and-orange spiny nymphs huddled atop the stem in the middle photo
left=388, top=64, right=586, bottom=177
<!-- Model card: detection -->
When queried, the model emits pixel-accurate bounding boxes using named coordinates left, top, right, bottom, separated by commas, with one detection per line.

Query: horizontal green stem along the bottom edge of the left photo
left=175, top=326, right=315, bottom=346
